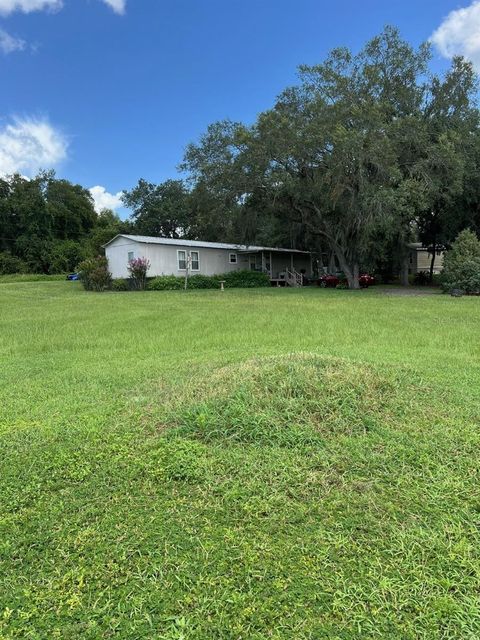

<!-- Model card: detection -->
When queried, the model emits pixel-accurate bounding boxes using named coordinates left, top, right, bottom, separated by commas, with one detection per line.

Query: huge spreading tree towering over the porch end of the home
left=184, top=28, right=480, bottom=287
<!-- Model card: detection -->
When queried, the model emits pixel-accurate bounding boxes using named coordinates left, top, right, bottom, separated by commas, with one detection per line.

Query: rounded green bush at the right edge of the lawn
left=441, top=229, right=480, bottom=295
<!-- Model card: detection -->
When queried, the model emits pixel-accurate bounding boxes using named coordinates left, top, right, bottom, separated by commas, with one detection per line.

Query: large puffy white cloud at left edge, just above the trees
left=0, top=118, right=68, bottom=176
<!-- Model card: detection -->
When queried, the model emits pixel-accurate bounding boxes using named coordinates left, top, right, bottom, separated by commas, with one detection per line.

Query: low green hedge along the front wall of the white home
left=147, top=271, right=270, bottom=291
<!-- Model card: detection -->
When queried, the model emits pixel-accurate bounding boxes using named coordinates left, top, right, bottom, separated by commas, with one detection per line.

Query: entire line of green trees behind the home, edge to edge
left=0, top=27, right=480, bottom=288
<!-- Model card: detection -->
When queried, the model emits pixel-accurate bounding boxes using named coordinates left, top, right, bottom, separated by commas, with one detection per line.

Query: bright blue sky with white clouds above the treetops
left=0, top=0, right=480, bottom=215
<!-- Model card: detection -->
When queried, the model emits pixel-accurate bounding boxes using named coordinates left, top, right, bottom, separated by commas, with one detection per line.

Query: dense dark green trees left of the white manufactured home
left=0, top=172, right=129, bottom=274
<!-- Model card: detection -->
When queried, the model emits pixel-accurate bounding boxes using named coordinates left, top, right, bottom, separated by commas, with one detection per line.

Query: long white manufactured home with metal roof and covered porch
left=104, top=234, right=312, bottom=286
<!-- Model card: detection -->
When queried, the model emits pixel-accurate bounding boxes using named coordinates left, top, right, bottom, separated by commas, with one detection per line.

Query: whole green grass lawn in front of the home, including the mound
left=0, top=280, right=480, bottom=640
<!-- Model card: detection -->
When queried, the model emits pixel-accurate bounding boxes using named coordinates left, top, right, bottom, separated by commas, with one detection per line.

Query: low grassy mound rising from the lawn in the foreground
left=173, top=354, right=408, bottom=446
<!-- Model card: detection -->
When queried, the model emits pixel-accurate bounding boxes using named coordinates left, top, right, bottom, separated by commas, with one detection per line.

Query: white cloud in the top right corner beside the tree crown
left=430, top=0, right=480, bottom=69
